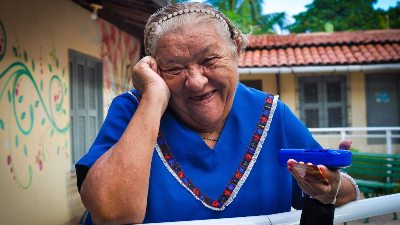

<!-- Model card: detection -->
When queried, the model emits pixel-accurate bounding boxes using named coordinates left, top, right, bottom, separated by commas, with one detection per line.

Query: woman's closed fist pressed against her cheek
left=132, top=56, right=171, bottom=107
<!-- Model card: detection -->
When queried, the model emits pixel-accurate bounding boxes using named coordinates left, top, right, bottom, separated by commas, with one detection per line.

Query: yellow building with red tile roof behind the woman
left=239, top=29, right=400, bottom=154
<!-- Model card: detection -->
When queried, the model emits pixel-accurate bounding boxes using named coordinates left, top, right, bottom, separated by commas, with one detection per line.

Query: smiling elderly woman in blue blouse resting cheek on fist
left=76, top=3, right=357, bottom=224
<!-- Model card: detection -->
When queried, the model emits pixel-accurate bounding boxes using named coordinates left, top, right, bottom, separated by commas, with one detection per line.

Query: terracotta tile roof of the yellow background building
left=239, top=29, right=400, bottom=67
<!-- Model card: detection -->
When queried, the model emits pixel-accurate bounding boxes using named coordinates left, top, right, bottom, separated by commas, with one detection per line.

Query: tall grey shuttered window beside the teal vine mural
left=69, top=50, right=103, bottom=168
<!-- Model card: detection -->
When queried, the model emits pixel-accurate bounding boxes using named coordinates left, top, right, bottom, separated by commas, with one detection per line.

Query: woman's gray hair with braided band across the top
left=144, top=2, right=248, bottom=57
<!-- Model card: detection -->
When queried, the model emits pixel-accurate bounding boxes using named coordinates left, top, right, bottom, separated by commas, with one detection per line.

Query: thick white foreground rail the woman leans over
left=144, top=193, right=400, bottom=225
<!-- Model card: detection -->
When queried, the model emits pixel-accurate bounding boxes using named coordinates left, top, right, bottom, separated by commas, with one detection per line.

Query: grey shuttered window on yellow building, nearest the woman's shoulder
left=298, top=75, right=348, bottom=128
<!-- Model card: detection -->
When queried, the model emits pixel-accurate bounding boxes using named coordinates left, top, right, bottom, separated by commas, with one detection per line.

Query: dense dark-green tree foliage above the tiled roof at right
left=287, top=0, right=382, bottom=33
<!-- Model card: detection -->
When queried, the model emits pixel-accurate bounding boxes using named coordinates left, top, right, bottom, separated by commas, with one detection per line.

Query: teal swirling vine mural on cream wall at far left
left=0, top=21, right=69, bottom=192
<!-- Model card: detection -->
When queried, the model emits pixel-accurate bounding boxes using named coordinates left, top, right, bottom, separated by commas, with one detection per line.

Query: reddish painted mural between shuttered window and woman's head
left=97, top=19, right=140, bottom=115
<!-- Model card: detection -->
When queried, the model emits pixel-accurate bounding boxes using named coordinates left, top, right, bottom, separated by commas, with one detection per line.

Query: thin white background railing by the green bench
left=309, top=127, right=400, bottom=154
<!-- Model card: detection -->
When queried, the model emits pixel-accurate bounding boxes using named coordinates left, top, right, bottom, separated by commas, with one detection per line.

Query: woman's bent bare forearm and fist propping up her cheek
left=80, top=57, right=170, bottom=224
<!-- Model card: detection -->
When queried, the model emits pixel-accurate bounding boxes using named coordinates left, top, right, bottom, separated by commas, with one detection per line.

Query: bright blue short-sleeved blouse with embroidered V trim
left=77, top=83, right=321, bottom=224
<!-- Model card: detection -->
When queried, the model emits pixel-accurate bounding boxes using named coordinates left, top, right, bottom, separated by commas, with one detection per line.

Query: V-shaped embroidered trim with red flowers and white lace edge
left=129, top=90, right=278, bottom=211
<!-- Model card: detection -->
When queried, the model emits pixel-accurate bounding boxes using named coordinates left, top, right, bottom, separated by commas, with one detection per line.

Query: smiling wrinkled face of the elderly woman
left=156, top=24, right=238, bottom=132
